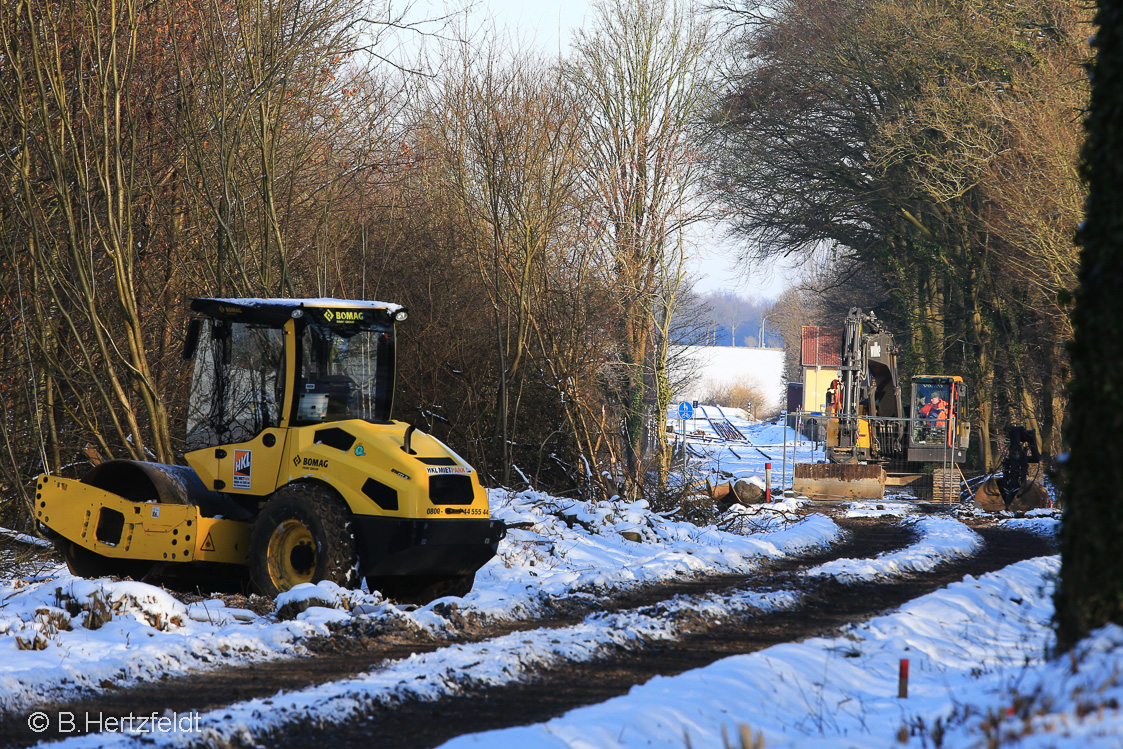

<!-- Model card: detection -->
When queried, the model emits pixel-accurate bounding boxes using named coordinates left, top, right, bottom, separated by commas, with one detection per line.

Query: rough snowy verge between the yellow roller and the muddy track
left=0, top=462, right=840, bottom=712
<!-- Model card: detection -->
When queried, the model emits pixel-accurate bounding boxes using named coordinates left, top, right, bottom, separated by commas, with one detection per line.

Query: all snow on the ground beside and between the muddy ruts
left=0, top=409, right=1096, bottom=748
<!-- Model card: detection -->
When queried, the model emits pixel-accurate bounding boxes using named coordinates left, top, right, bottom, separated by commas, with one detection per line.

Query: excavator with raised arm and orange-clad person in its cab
left=793, top=308, right=970, bottom=500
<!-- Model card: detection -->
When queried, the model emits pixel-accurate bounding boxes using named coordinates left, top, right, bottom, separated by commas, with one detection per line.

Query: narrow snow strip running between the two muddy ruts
left=24, top=494, right=1010, bottom=747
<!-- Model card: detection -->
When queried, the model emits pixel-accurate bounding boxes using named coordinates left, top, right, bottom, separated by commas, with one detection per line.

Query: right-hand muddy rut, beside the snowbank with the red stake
left=267, top=528, right=1056, bottom=749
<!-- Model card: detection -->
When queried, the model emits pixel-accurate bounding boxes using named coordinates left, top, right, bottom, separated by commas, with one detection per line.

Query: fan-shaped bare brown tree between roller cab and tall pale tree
left=427, top=42, right=582, bottom=485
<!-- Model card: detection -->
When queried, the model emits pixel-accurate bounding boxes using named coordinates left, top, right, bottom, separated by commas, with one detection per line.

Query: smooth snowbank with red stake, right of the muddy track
left=435, top=557, right=1096, bottom=749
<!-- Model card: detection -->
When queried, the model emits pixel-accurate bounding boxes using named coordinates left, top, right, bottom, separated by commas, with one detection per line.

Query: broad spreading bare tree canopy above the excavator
left=720, top=0, right=1087, bottom=467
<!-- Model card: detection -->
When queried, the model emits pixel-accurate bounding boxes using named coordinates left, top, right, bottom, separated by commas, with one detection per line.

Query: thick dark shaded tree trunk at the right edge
left=1056, top=0, right=1123, bottom=651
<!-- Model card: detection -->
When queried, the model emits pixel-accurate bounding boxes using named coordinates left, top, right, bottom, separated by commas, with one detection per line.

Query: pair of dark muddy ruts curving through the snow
left=0, top=520, right=1053, bottom=747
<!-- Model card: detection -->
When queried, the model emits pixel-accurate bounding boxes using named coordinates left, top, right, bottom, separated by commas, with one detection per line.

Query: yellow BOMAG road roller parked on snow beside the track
left=35, top=299, right=505, bottom=602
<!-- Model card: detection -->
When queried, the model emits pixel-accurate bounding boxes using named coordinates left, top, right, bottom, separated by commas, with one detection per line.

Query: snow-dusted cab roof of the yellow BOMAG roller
left=191, top=298, right=405, bottom=326
